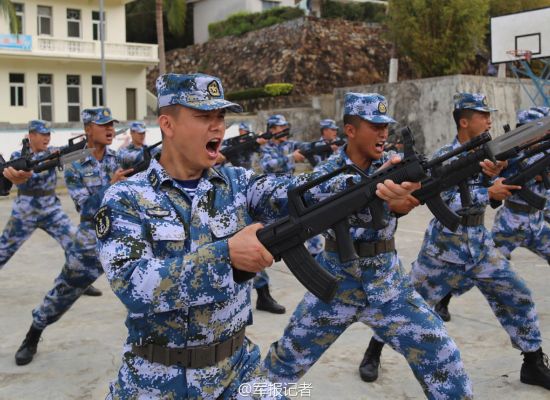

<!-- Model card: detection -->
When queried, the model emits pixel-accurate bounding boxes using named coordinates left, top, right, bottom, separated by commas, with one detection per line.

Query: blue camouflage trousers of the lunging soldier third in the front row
left=411, top=246, right=541, bottom=352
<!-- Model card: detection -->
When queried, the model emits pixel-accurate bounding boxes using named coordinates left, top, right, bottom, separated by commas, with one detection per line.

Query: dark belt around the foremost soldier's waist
left=132, top=328, right=245, bottom=368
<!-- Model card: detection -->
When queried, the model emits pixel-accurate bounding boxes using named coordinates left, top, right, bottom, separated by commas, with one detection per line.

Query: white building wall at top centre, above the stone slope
left=193, top=0, right=295, bottom=43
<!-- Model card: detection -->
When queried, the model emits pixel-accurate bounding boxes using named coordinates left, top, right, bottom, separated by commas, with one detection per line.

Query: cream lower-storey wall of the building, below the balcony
left=0, top=59, right=147, bottom=124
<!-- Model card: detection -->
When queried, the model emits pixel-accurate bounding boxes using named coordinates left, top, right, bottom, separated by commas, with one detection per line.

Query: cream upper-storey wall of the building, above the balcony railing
left=0, top=0, right=126, bottom=43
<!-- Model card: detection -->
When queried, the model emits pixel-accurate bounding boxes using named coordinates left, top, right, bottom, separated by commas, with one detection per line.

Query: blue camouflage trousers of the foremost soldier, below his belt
left=107, top=339, right=287, bottom=400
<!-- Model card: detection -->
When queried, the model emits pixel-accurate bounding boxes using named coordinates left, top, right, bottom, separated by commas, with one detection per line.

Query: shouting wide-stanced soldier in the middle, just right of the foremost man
left=263, top=93, right=472, bottom=399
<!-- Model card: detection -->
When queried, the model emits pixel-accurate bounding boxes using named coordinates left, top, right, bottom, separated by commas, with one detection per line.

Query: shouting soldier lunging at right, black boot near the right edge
left=362, top=93, right=550, bottom=390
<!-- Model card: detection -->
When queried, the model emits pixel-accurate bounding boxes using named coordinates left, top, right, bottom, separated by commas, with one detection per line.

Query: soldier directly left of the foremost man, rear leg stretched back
left=15, top=107, right=131, bottom=365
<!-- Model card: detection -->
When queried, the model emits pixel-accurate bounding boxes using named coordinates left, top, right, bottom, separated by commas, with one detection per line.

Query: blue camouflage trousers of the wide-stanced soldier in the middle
left=263, top=252, right=473, bottom=399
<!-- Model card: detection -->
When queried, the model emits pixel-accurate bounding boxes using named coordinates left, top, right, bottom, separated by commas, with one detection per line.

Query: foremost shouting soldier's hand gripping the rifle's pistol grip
left=227, top=224, right=273, bottom=272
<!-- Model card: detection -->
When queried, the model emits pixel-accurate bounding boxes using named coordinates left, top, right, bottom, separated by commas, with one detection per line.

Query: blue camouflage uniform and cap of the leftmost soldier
left=0, top=120, right=75, bottom=269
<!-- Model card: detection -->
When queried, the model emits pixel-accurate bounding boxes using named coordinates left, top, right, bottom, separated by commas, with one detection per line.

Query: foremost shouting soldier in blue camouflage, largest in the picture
left=96, top=74, right=366, bottom=399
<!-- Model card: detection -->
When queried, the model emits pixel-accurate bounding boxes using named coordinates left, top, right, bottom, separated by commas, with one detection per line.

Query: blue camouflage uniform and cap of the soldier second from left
left=32, top=108, right=120, bottom=329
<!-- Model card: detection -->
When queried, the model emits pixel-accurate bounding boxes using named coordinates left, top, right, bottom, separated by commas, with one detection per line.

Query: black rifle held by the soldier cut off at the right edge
left=490, top=135, right=550, bottom=210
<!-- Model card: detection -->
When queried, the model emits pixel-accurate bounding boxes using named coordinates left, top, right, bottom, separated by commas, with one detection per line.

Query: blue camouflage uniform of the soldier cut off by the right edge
left=492, top=109, right=550, bottom=264
